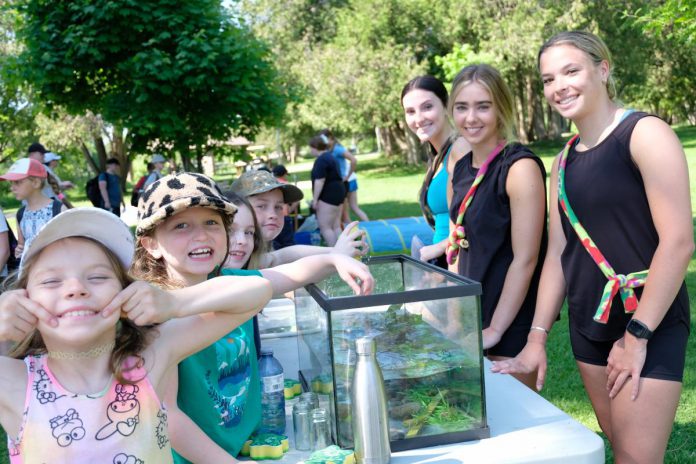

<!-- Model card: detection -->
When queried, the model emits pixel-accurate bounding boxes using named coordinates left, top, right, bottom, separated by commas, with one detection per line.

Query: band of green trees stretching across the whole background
left=0, top=0, right=696, bottom=179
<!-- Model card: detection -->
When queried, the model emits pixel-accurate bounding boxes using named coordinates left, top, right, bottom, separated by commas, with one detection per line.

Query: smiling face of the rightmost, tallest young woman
left=539, top=45, right=609, bottom=120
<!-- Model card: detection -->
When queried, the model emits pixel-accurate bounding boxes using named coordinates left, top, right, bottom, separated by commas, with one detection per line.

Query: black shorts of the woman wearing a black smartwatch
left=570, top=322, right=689, bottom=382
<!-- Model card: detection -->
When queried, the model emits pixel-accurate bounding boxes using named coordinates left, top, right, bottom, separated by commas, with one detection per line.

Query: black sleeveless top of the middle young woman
left=450, top=143, right=547, bottom=329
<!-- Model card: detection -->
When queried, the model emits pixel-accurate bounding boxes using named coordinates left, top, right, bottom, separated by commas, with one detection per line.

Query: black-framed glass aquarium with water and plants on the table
left=295, top=255, right=490, bottom=451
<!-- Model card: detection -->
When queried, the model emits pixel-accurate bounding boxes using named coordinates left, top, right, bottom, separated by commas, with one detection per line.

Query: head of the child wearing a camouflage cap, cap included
left=230, top=170, right=304, bottom=243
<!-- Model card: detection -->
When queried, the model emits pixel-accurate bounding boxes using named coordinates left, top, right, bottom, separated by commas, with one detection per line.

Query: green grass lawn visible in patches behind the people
left=0, top=127, right=696, bottom=464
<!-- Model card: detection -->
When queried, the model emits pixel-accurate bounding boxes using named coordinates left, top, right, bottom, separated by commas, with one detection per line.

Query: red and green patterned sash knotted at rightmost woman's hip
left=558, top=135, right=648, bottom=324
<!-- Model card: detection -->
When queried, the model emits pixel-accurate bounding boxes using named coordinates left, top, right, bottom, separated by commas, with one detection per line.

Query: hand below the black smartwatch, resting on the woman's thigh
left=606, top=335, right=648, bottom=401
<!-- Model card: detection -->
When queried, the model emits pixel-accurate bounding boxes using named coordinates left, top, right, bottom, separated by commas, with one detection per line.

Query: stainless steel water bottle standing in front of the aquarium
left=351, top=337, right=391, bottom=464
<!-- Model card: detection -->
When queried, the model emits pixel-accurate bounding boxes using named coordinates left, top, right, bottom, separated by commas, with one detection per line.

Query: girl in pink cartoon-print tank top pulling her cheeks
left=0, top=208, right=270, bottom=464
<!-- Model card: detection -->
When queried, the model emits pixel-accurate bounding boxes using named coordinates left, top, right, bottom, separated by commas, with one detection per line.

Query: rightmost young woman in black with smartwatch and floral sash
left=494, top=32, right=694, bottom=463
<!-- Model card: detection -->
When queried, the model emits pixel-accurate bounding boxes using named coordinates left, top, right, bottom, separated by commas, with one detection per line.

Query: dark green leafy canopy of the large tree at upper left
left=14, top=0, right=285, bottom=163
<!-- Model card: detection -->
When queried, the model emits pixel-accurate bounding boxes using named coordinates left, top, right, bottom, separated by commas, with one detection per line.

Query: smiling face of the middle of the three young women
left=452, top=81, right=500, bottom=148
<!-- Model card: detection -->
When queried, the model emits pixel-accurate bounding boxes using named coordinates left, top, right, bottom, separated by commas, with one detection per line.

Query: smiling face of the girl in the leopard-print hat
left=140, top=206, right=227, bottom=286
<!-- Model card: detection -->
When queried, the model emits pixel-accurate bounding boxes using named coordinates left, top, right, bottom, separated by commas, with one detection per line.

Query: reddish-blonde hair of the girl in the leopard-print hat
left=130, top=207, right=232, bottom=290
